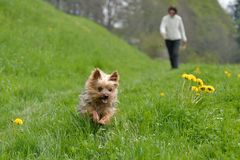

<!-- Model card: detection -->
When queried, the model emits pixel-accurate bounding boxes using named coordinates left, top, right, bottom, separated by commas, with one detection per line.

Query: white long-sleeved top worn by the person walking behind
left=160, top=15, right=187, bottom=42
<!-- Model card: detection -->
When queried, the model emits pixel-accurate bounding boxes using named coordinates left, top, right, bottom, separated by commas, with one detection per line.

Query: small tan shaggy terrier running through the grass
left=78, top=69, right=119, bottom=125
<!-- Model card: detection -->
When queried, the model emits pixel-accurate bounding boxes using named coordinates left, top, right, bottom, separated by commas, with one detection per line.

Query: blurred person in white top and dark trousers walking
left=160, top=6, right=187, bottom=69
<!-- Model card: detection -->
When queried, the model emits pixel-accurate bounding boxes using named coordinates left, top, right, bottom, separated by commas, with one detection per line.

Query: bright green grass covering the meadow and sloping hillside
left=0, top=0, right=240, bottom=160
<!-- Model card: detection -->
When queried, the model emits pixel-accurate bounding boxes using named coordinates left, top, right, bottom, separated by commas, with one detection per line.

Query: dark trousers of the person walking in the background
left=165, top=40, right=181, bottom=69
